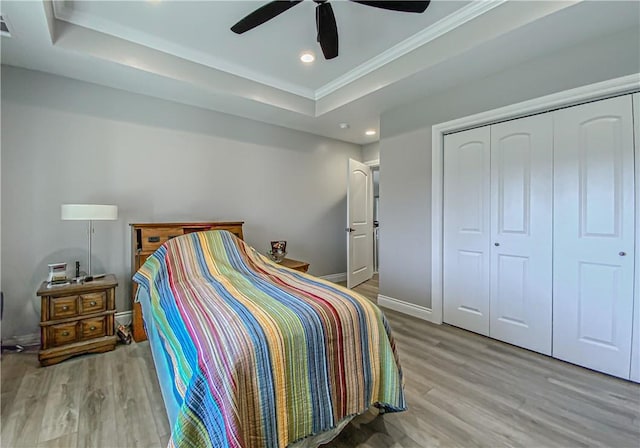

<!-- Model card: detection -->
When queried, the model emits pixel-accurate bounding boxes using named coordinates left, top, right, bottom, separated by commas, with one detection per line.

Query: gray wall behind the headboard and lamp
left=1, top=66, right=361, bottom=338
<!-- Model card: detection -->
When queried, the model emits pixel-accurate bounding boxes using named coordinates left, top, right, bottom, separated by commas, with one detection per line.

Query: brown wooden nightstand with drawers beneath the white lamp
left=37, top=274, right=118, bottom=366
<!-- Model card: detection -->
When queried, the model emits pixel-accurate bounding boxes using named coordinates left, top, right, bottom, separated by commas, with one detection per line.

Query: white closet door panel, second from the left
left=489, top=113, right=553, bottom=355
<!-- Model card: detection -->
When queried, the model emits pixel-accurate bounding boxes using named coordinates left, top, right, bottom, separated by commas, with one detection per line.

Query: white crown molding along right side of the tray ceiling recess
left=315, top=0, right=507, bottom=100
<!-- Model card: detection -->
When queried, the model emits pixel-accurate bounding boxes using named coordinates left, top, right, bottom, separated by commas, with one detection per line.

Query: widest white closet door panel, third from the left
left=553, top=95, right=634, bottom=378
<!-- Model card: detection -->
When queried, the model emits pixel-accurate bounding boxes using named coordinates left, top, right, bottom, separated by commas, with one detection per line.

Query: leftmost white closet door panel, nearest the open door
left=443, top=126, right=491, bottom=336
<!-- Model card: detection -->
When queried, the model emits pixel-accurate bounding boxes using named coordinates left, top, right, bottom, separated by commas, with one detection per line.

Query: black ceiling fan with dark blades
left=231, top=0, right=431, bottom=59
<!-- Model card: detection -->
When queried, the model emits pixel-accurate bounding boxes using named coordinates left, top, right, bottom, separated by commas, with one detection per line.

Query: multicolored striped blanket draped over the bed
left=134, top=231, right=406, bottom=448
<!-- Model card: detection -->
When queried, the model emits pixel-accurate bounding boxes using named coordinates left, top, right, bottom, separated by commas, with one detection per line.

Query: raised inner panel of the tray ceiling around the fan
left=54, top=0, right=469, bottom=98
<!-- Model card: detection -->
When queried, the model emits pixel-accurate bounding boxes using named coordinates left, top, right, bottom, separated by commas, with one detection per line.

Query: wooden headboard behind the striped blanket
left=130, top=221, right=244, bottom=342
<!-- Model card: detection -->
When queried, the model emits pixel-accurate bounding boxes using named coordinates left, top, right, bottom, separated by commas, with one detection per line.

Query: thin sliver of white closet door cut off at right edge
left=631, top=93, right=640, bottom=383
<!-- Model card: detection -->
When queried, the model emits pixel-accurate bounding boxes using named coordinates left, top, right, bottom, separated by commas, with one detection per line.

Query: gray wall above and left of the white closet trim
left=380, top=29, right=640, bottom=308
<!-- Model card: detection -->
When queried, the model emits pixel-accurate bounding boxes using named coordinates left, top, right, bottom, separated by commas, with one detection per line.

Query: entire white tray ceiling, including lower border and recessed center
left=0, top=0, right=640, bottom=144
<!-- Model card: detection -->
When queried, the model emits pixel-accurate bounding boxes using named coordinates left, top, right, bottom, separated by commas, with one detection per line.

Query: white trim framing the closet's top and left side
left=429, top=73, right=640, bottom=324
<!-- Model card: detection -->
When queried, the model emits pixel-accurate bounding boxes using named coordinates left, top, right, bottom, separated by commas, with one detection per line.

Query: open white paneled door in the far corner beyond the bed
left=346, top=159, right=373, bottom=288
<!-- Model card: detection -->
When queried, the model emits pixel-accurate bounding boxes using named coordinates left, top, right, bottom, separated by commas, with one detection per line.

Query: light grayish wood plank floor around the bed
left=0, top=278, right=640, bottom=448
